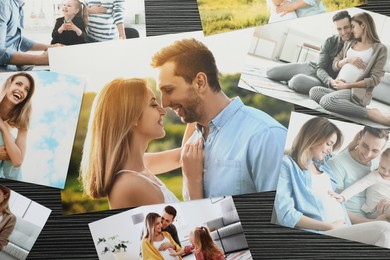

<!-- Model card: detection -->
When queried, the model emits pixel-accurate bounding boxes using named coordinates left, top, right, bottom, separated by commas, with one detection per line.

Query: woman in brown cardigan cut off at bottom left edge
left=0, top=184, right=16, bottom=251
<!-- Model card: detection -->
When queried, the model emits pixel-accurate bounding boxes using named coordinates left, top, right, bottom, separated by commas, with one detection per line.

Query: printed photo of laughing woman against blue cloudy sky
left=0, top=71, right=85, bottom=188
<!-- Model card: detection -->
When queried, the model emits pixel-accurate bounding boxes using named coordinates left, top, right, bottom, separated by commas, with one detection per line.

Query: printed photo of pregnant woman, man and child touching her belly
left=272, top=113, right=390, bottom=248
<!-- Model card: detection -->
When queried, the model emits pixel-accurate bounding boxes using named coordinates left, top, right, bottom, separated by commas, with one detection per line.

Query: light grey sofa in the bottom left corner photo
left=0, top=217, right=42, bottom=260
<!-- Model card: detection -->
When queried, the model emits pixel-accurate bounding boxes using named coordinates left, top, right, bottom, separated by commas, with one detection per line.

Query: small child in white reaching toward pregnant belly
left=332, top=148, right=390, bottom=218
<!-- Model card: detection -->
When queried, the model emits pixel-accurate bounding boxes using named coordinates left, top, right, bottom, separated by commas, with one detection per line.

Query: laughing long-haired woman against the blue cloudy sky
left=0, top=72, right=35, bottom=180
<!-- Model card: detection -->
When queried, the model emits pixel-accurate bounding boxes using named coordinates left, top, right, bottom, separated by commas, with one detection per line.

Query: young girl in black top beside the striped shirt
left=51, top=0, right=88, bottom=45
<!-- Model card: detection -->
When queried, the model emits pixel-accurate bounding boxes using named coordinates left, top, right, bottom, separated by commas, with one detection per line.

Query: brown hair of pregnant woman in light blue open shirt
left=290, top=117, right=343, bottom=170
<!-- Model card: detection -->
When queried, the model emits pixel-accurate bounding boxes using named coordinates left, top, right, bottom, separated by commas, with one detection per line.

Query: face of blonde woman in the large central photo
left=134, top=90, right=166, bottom=139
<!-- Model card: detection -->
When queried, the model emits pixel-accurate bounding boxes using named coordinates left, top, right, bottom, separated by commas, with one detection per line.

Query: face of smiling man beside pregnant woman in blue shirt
left=353, top=132, right=386, bottom=165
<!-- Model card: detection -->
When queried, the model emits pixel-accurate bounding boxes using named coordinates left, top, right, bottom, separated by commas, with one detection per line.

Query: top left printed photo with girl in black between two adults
left=0, top=0, right=146, bottom=71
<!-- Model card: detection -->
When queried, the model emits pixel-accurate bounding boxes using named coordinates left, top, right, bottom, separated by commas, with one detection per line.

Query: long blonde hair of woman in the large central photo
left=80, top=78, right=150, bottom=199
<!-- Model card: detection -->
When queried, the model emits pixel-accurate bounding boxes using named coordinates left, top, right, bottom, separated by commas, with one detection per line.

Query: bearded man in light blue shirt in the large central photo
left=151, top=39, right=287, bottom=199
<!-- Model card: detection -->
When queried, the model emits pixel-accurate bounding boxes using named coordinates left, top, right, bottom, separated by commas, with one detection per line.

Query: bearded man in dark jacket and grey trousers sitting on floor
left=267, top=11, right=359, bottom=94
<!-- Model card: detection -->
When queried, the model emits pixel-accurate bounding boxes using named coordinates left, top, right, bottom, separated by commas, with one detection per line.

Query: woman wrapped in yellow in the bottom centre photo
left=141, top=212, right=182, bottom=260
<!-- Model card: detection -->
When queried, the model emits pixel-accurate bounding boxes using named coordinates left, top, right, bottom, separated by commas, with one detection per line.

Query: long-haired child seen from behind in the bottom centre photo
left=168, top=226, right=225, bottom=260
